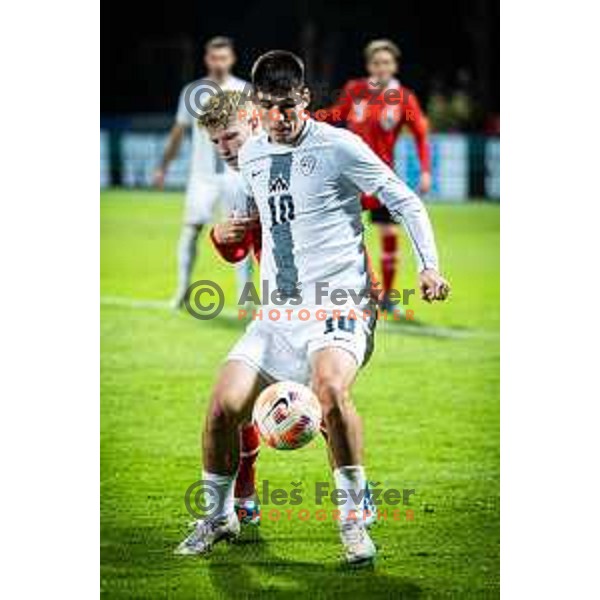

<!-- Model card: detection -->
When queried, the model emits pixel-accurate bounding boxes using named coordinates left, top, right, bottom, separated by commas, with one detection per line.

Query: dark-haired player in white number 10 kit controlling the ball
left=179, top=51, right=449, bottom=565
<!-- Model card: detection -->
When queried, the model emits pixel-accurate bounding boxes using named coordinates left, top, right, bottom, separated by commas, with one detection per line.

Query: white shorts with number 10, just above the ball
left=227, top=307, right=376, bottom=385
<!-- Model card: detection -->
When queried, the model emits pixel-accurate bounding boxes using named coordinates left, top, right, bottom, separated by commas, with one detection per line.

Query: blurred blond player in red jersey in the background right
left=326, top=40, right=431, bottom=309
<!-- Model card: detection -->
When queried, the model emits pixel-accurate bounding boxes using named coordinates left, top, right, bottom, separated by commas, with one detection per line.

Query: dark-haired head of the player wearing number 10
left=252, top=50, right=310, bottom=144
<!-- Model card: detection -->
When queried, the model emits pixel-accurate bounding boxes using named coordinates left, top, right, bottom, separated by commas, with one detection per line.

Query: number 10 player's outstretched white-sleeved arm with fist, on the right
left=337, top=132, right=450, bottom=302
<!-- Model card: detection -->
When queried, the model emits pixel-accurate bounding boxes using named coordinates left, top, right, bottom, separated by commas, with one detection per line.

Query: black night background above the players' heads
left=101, top=0, right=499, bottom=132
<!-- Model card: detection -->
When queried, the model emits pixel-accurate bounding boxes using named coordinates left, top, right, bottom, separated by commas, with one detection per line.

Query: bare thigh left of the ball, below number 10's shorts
left=211, top=359, right=268, bottom=422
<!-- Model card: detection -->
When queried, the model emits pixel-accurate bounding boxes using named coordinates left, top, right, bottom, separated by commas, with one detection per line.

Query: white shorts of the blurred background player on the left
left=183, top=173, right=246, bottom=225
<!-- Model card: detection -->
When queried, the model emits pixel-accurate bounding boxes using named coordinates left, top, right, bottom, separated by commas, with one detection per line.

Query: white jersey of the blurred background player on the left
left=175, top=75, right=250, bottom=182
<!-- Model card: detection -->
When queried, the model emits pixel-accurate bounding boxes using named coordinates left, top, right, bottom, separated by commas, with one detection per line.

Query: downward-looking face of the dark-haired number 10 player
left=257, top=90, right=308, bottom=144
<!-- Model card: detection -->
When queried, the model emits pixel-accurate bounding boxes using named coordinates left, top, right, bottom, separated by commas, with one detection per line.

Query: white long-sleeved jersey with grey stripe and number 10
left=239, top=119, right=437, bottom=307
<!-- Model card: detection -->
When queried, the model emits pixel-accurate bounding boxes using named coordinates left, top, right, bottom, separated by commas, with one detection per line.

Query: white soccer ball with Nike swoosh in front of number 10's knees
left=252, top=381, right=321, bottom=450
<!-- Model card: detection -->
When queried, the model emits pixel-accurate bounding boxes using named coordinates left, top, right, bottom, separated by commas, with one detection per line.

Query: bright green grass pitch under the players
left=101, top=191, right=499, bottom=598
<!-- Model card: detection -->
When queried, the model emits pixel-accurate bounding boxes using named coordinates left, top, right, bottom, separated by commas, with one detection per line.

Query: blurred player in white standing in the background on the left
left=154, top=37, right=252, bottom=308
